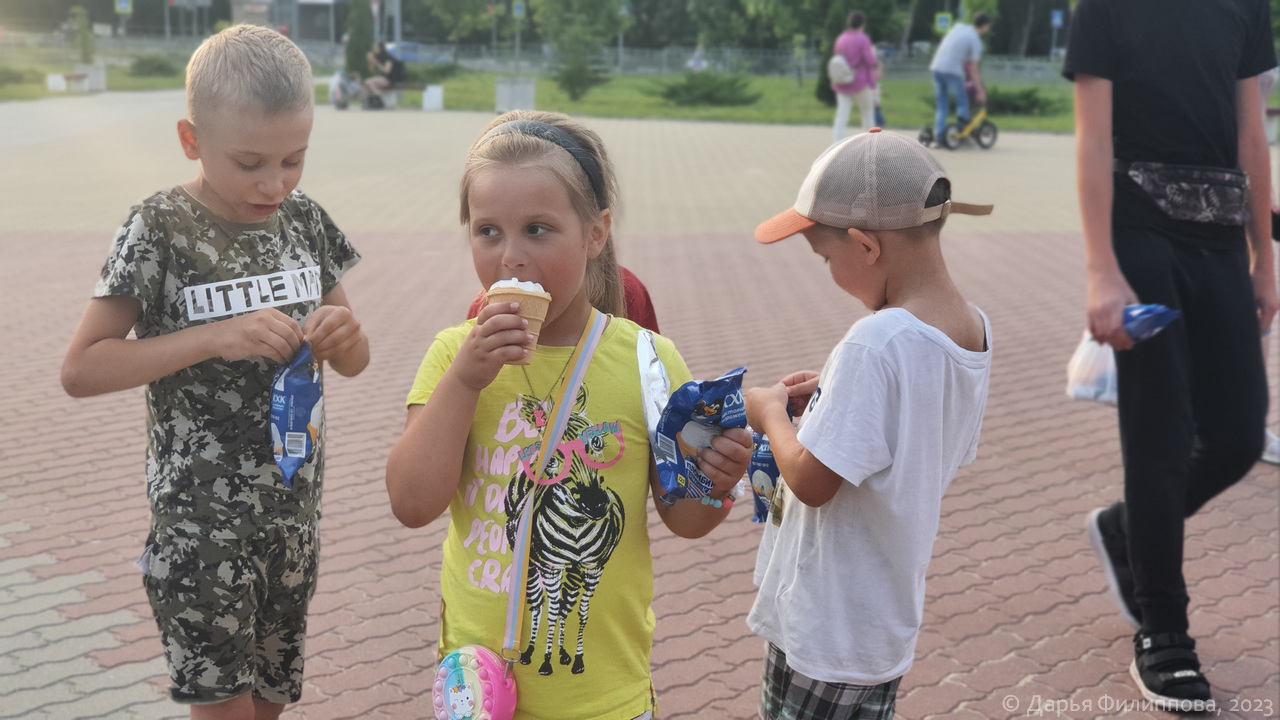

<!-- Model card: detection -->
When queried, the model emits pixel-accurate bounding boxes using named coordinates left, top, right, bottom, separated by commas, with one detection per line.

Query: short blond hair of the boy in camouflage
left=187, top=24, right=315, bottom=127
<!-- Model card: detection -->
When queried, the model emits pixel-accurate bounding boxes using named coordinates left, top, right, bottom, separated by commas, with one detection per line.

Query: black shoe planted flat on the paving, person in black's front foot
left=1129, top=633, right=1216, bottom=712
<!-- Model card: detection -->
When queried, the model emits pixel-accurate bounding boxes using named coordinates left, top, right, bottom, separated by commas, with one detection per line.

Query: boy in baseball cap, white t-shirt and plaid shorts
left=746, top=128, right=991, bottom=720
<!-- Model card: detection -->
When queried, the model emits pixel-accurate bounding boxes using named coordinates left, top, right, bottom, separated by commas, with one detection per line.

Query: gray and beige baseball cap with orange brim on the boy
left=755, top=128, right=993, bottom=242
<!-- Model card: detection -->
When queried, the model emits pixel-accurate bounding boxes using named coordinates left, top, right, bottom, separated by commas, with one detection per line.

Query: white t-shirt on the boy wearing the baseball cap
left=746, top=307, right=991, bottom=685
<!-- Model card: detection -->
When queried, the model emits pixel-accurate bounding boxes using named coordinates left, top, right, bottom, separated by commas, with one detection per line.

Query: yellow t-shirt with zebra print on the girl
left=408, top=318, right=690, bottom=720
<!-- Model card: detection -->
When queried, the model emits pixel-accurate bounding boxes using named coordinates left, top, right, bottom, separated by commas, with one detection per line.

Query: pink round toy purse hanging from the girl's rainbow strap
left=431, top=644, right=516, bottom=720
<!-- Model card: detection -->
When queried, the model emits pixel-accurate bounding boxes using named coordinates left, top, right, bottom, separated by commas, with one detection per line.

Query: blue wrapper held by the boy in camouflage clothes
left=271, top=343, right=324, bottom=488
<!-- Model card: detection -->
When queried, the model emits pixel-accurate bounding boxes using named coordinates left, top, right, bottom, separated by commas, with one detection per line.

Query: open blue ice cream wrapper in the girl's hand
left=653, top=368, right=746, bottom=505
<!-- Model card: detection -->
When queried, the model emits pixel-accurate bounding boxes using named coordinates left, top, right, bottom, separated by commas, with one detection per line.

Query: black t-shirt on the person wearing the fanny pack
left=1062, top=0, right=1276, bottom=243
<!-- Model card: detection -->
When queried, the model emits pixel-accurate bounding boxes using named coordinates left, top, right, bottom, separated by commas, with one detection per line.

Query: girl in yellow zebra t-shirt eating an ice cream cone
left=387, top=110, right=751, bottom=720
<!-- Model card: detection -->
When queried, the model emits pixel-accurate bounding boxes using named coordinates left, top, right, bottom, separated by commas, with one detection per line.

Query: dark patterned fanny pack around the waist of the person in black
left=1115, top=160, right=1249, bottom=227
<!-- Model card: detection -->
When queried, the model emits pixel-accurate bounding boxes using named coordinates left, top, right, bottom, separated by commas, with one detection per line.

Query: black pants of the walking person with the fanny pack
left=1114, top=228, right=1267, bottom=633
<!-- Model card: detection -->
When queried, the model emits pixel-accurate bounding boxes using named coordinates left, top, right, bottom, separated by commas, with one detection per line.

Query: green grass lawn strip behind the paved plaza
left=0, top=67, right=1073, bottom=132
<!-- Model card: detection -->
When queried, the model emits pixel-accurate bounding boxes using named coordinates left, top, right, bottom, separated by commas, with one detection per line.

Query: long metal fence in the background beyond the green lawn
left=0, top=32, right=1065, bottom=82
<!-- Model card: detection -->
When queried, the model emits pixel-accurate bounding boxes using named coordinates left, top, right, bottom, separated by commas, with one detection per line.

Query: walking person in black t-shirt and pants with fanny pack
left=1064, top=0, right=1276, bottom=710
